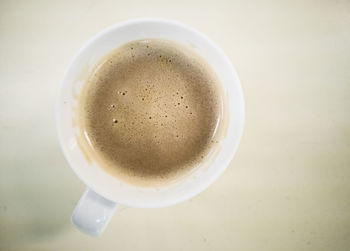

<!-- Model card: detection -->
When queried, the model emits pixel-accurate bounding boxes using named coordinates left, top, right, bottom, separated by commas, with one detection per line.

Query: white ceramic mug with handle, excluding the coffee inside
left=56, top=18, right=244, bottom=236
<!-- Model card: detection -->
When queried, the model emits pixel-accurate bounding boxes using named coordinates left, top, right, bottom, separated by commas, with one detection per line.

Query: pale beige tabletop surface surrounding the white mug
left=0, top=0, right=350, bottom=251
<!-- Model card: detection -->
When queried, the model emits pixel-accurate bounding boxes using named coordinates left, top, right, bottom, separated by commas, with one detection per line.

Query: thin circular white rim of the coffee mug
left=55, top=18, right=245, bottom=208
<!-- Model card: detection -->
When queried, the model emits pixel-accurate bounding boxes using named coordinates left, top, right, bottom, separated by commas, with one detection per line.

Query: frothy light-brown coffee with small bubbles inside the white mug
left=78, top=39, right=223, bottom=186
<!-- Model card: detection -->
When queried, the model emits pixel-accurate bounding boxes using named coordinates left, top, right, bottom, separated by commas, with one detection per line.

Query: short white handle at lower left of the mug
left=71, top=188, right=117, bottom=236
